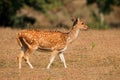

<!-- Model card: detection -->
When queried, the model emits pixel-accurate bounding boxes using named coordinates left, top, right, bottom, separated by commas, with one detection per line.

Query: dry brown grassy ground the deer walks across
left=0, top=28, right=120, bottom=80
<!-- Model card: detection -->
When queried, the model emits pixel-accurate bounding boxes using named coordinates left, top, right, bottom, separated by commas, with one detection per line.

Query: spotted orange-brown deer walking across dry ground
left=17, top=18, right=88, bottom=69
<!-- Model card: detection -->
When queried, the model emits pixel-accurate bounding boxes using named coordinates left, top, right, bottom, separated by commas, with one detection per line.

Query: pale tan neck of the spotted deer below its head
left=68, top=26, right=80, bottom=43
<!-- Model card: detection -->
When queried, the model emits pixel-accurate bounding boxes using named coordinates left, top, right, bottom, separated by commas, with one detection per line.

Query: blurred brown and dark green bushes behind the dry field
left=0, top=0, right=120, bottom=29
